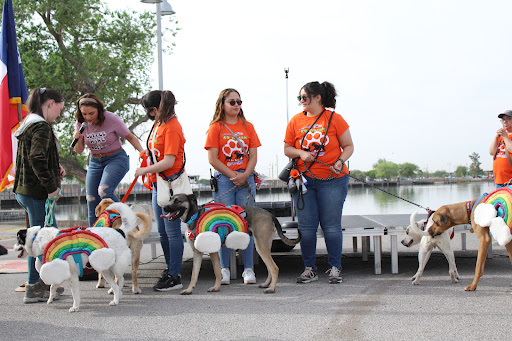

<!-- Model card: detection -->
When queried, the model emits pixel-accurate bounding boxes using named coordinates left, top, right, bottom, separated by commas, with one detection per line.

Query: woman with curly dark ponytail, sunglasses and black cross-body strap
left=284, top=82, right=354, bottom=284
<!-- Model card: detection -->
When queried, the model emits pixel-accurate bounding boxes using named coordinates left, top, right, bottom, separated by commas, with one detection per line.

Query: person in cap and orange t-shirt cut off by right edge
left=489, top=110, right=512, bottom=189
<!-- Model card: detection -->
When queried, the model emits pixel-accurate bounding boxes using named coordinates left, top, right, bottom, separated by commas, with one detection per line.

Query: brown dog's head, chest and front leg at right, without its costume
left=426, top=198, right=506, bottom=291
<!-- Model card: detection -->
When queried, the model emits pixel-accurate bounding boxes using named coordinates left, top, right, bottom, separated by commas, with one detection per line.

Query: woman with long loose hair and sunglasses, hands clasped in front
left=204, top=89, right=261, bottom=284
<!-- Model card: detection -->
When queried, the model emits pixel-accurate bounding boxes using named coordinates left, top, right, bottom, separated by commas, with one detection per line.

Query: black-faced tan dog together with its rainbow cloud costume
left=163, top=194, right=300, bottom=295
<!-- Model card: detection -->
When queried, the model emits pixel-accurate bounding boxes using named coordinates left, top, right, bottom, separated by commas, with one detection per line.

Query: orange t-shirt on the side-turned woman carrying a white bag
left=148, top=117, right=185, bottom=182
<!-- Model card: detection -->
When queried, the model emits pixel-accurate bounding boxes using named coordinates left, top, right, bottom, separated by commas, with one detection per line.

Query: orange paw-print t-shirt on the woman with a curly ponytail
left=284, top=110, right=348, bottom=178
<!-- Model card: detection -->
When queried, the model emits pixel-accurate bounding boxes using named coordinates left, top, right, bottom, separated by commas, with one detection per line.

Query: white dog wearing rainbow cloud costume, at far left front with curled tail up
left=16, top=203, right=137, bottom=312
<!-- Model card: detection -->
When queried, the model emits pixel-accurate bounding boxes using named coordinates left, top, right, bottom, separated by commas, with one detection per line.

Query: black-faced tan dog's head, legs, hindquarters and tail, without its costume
left=164, top=194, right=300, bottom=295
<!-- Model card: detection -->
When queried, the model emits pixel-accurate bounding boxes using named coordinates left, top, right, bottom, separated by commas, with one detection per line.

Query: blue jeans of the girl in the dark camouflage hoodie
left=15, top=194, right=57, bottom=285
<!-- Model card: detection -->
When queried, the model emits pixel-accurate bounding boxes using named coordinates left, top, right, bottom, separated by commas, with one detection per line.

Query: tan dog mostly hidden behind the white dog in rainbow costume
left=95, top=199, right=153, bottom=294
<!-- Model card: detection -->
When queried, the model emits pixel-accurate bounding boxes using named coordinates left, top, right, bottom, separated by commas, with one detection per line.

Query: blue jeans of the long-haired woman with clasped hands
left=213, top=170, right=256, bottom=269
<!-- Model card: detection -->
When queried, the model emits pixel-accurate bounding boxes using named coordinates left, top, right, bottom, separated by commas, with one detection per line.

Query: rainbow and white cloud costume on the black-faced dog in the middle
left=187, top=203, right=250, bottom=253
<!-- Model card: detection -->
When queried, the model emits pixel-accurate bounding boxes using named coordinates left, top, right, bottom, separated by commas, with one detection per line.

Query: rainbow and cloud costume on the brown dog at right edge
left=475, top=186, right=512, bottom=246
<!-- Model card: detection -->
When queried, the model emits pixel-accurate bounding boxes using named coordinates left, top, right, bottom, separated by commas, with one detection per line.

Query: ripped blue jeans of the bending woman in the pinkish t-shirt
left=85, top=149, right=130, bottom=226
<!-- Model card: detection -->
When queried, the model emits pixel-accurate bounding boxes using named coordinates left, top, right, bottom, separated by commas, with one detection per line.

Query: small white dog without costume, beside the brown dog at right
left=402, top=212, right=459, bottom=285
